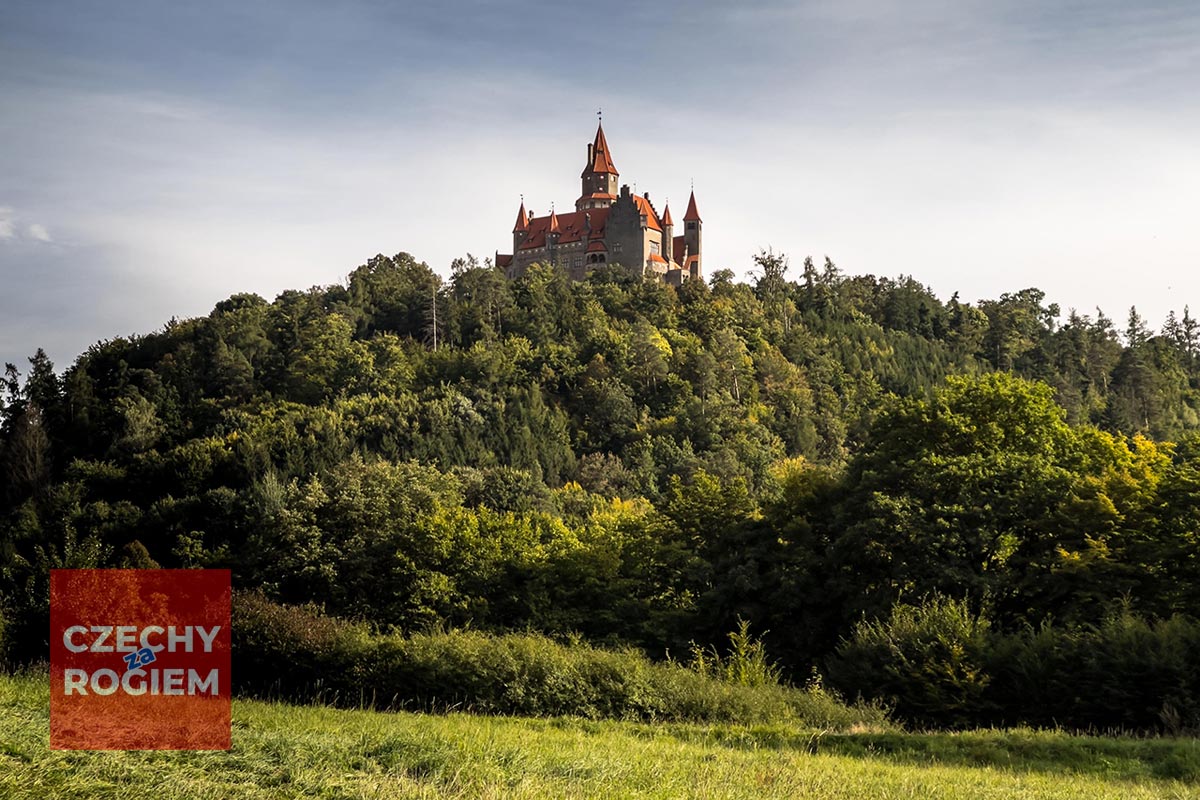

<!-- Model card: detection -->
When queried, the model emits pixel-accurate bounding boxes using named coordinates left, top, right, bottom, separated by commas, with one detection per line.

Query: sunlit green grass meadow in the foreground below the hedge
left=0, top=675, right=1200, bottom=800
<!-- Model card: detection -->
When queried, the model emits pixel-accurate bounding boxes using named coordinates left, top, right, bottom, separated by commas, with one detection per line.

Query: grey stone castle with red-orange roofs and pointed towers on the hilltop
left=496, top=124, right=702, bottom=284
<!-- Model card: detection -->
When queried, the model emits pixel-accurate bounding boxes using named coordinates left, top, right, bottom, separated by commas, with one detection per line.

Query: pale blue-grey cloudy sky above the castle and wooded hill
left=0, top=0, right=1200, bottom=369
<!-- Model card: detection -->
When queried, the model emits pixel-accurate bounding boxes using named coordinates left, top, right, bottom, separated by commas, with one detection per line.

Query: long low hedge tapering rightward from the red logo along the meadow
left=233, top=594, right=886, bottom=729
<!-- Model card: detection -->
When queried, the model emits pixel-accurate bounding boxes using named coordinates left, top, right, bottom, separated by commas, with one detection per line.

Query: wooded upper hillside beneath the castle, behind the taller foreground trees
left=11, top=253, right=1200, bottom=484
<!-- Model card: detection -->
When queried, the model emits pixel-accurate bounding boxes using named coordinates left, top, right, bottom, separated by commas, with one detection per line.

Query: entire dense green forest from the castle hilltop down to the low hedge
left=0, top=252, right=1200, bottom=727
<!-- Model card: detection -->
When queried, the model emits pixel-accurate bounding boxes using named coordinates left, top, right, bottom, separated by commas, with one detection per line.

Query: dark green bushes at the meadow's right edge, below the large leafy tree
left=829, top=597, right=1200, bottom=734
